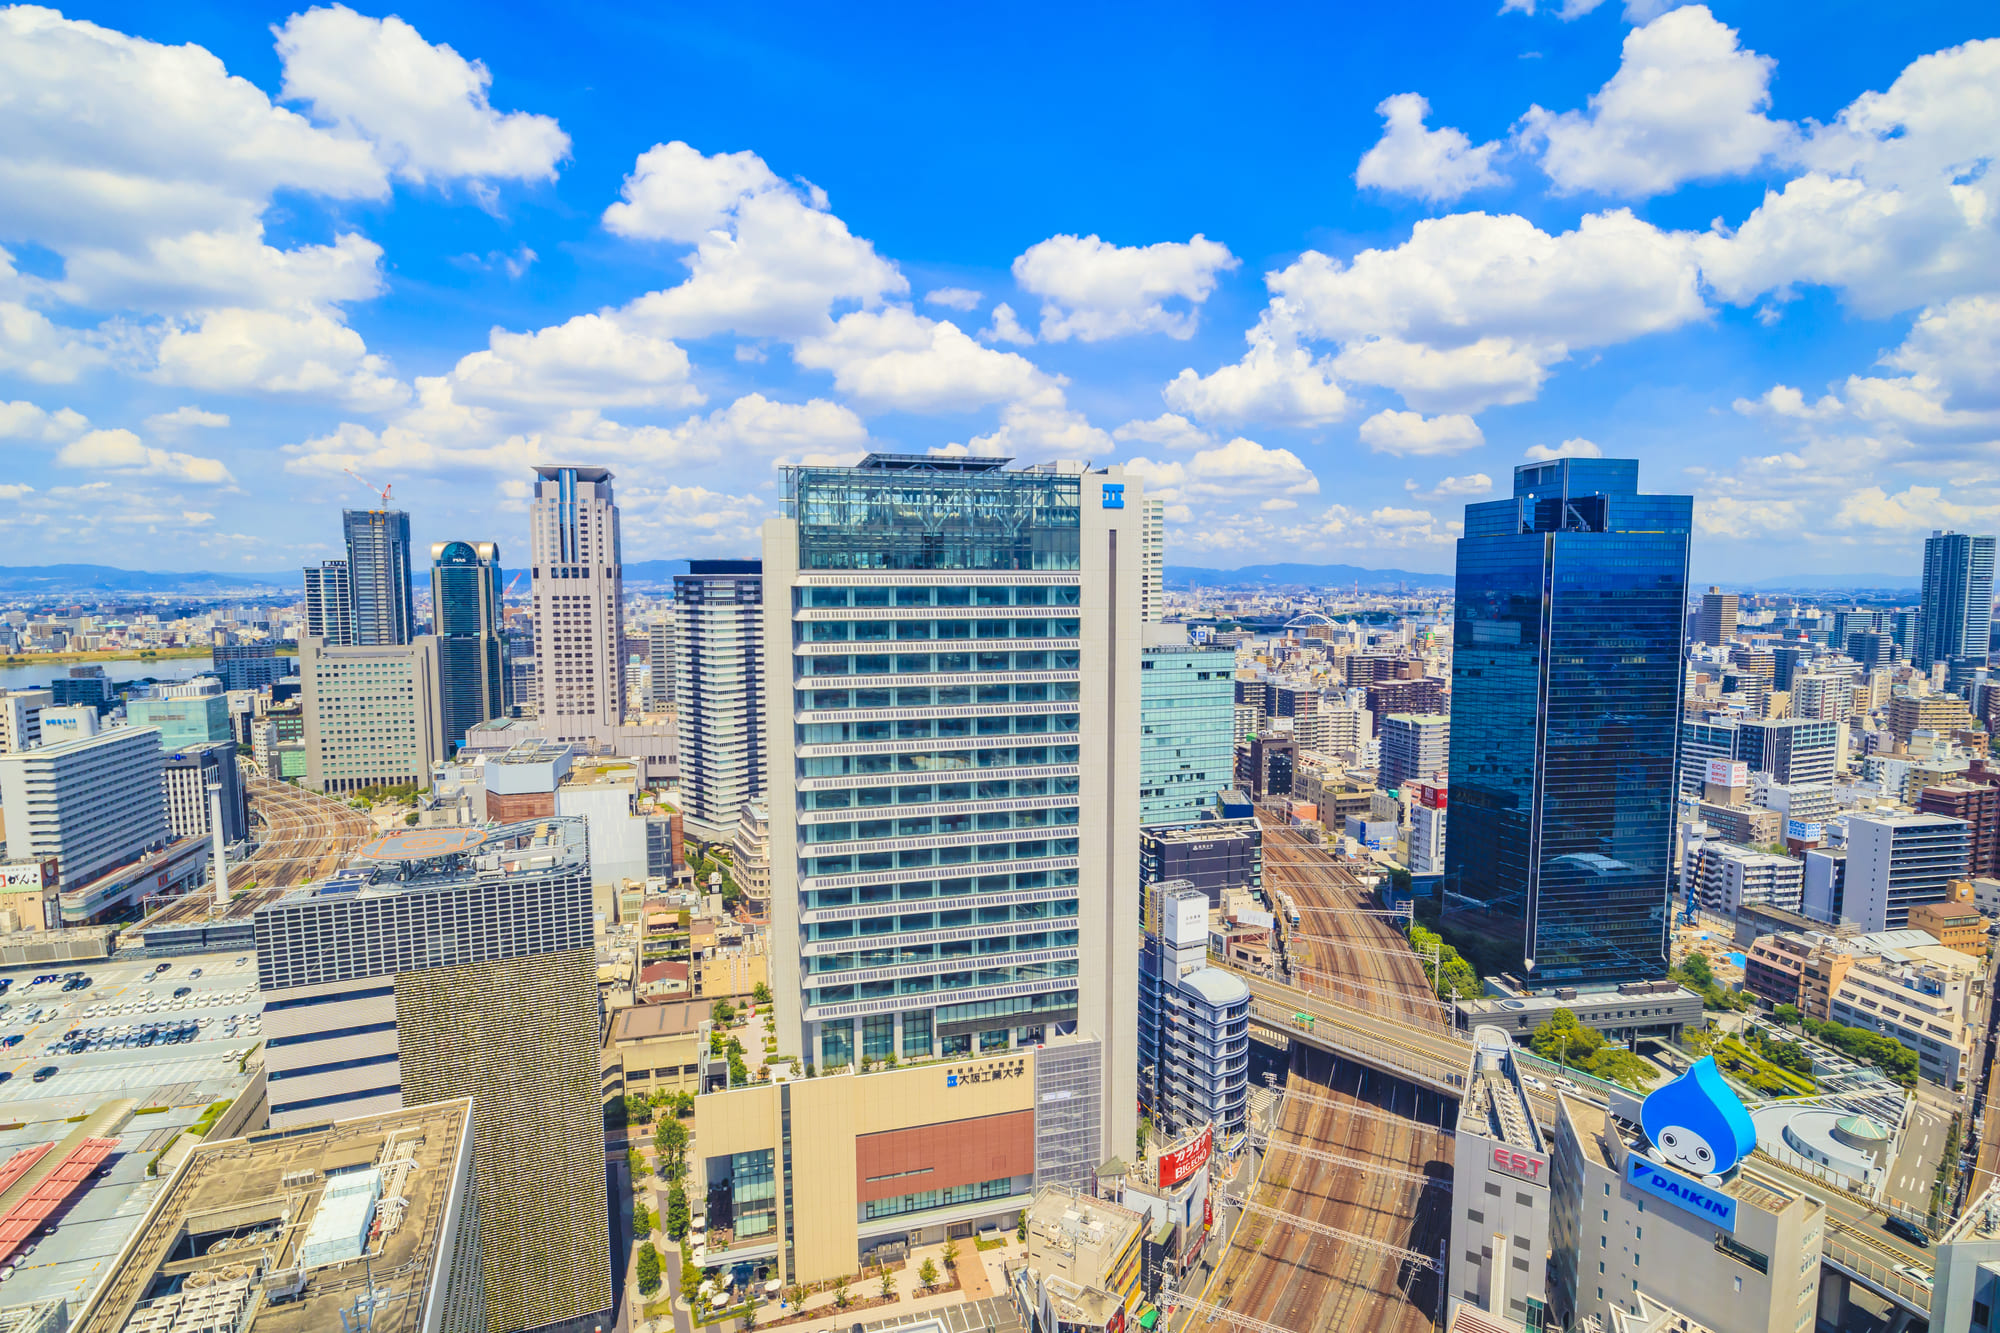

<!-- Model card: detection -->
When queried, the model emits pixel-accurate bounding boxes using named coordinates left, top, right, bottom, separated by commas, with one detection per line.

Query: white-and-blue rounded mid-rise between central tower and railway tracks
left=1138, top=881, right=1250, bottom=1137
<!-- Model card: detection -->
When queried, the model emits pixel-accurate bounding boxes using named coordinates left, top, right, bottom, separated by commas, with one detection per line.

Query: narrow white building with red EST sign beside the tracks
left=1444, top=1027, right=1552, bottom=1327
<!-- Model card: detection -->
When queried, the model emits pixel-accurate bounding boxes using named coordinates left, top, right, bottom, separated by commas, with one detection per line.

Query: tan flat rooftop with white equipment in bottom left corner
left=72, top=1097, right=472, bottom=1333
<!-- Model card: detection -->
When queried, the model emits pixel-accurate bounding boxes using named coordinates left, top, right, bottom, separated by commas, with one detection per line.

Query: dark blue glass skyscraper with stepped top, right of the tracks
left=1444, top=458, right=1694, bottom=985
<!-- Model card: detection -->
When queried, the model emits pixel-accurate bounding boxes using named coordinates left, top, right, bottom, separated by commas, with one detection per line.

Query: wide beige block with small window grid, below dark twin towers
left=298, top=634, right=444, bottom=793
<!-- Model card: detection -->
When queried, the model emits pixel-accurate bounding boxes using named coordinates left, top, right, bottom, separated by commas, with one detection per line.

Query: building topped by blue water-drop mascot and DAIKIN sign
left=1544, top=1059, right=1826, bottom=1333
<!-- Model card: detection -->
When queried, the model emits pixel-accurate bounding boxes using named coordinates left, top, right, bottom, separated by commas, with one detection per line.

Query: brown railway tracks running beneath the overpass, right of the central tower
left=1206, top=808, right=1452, bottom=1333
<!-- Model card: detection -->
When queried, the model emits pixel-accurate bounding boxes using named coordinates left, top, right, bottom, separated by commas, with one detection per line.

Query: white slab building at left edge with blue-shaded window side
left=0, top=727, right=168, bottom=893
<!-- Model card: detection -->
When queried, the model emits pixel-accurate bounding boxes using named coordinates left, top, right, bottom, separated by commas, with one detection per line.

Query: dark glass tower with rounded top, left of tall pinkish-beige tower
left=430, top=542, right=514, bottom=757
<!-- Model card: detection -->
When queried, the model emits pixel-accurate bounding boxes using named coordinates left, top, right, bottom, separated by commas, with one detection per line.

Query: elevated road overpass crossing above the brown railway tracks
left=1212, top=961, right=1932, bottom=1319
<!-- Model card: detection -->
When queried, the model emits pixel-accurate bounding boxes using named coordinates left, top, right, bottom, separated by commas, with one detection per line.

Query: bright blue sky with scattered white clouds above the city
left=0, top=0, right=2000, bottom=578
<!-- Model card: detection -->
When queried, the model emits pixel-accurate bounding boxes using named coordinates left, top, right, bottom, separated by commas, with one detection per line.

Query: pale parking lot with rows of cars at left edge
left=0, top=953, right=262, bottom=1311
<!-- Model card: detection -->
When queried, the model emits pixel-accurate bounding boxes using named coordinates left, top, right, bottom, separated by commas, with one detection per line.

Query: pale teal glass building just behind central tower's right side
left=1138, top=640, right=1236, bottom=825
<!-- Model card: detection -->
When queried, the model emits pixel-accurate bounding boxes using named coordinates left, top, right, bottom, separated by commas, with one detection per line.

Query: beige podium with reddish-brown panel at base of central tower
left=694, top=1037, right=1104, bottom=1283
